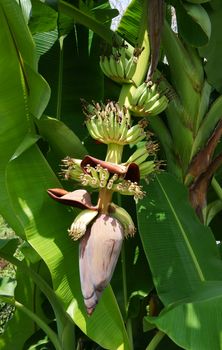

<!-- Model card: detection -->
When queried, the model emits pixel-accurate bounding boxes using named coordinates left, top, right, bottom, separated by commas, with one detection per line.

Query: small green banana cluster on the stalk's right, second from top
left=130, top=82, right=168, bottom=117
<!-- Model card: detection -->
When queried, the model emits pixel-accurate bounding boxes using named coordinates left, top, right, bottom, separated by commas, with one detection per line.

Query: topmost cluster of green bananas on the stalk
left=100, top=44, right=142, bottom=84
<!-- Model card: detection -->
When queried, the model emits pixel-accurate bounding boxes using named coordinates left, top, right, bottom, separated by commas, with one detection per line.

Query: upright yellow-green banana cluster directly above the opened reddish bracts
left=84, top=101, right=146, bottom=145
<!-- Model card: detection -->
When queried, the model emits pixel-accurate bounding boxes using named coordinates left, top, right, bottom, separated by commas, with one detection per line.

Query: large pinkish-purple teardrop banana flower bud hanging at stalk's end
left=79, top=214, right=124, bottom=315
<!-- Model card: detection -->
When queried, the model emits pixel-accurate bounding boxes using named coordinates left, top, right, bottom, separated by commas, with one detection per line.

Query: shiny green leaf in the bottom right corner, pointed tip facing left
left=146, top=281, right=222, bottom=350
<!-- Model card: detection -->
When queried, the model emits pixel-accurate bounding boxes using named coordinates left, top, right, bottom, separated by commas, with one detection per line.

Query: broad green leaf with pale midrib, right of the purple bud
left=137, top=173, right=222, bottom=305
